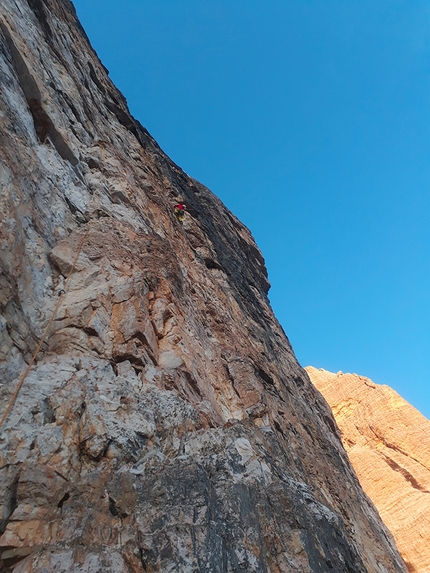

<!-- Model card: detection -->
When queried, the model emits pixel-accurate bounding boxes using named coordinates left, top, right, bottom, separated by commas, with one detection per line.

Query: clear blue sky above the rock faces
left=74, top=0, right=430, bottom=417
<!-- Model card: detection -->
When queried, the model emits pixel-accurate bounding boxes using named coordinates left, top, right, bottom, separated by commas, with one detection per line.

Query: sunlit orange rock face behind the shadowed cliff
left=306, top=367, right=430, bottom=573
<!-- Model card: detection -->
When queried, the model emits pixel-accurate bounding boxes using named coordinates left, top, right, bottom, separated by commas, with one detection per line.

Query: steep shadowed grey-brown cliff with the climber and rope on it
left=0, top=0, right=406, bottom=573
